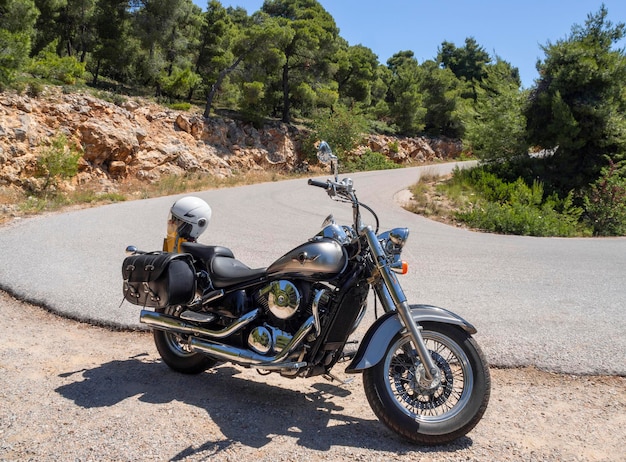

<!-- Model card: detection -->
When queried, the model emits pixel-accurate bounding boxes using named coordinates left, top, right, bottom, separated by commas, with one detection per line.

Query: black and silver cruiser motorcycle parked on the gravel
left=122, top=142, right=490, bottom=445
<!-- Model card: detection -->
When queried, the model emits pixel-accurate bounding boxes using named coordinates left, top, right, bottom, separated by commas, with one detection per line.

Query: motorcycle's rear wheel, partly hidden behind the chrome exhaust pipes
left=153, top=307, right=217, bottom=374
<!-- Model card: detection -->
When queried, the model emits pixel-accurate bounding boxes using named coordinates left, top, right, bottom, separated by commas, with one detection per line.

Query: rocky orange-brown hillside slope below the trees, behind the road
left=0, top=87, right=460, bottom=194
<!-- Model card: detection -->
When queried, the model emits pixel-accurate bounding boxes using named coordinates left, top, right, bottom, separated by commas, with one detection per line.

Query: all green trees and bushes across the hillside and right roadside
left=0, top=0, right=626, bottom=235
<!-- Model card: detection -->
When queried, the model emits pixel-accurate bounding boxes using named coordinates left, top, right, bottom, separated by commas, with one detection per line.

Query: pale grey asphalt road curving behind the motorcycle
left=0, top=164, right=626, bottom=375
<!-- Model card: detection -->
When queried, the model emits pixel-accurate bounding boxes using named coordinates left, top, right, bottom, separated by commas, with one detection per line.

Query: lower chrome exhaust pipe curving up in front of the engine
left=189, top=316, right=315, bottom=370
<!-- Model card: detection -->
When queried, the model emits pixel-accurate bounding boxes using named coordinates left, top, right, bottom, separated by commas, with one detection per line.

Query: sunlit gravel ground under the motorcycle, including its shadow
left=0, top=293, right=626, bottom=462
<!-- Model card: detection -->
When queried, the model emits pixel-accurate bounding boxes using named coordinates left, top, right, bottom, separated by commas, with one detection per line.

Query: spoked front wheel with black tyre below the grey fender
left=363, top=323, right=491, bottom=445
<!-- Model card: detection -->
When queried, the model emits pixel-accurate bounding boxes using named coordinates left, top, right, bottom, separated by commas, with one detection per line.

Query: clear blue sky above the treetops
left=193, top=0, right=626, bottom=88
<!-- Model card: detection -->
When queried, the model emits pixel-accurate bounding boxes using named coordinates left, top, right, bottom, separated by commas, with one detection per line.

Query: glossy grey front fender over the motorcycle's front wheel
left=346, top=305, right=476, bottom=374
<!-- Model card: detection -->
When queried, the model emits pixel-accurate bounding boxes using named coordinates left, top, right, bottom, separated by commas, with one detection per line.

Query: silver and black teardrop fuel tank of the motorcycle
left=267, top=238, right=348, bottom=278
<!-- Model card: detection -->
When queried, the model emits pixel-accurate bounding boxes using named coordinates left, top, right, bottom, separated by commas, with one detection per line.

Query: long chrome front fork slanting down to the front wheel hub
left=362, top=226, right=439, bottom=381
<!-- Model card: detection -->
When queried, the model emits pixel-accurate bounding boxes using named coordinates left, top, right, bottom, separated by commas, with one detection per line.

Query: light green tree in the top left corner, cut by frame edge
left=0, top=0, right=39, bottom=85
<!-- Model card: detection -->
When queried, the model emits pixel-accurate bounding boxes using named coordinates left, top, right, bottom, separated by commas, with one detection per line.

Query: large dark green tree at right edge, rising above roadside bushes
left=526, top=5, right=626, bottom=192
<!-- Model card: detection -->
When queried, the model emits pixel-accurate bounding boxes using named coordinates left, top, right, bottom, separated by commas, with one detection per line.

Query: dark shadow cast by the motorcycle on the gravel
left=55, top=354, right=472, bottom=454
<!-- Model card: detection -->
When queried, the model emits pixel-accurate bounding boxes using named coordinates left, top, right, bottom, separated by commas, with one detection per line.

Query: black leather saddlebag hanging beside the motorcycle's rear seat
left=122, top=252, right=196, bottom=308
